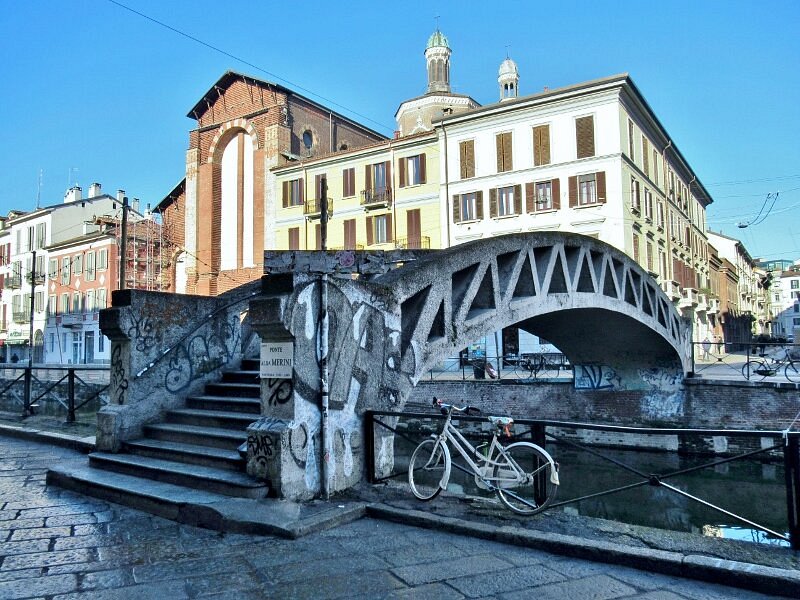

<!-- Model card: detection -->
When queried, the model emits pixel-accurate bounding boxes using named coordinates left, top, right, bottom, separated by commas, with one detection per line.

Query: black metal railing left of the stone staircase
left=0, top=365, right=109, bottom=423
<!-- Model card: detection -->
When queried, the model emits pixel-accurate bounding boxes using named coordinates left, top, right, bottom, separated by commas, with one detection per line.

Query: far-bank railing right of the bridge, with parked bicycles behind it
left=692, top=340, right=800, bottom=383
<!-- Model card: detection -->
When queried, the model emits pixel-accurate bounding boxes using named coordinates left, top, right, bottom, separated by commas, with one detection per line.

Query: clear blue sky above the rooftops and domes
left=0, top=0, right=800, bottom=259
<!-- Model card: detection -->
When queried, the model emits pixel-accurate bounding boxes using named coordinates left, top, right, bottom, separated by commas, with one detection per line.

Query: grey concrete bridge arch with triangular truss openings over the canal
left=376, top=232, right=691, bottom=383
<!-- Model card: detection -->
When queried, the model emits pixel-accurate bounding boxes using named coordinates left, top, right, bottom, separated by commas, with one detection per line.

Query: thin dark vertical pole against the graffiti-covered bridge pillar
left=319, top=177, right=331, bottom=499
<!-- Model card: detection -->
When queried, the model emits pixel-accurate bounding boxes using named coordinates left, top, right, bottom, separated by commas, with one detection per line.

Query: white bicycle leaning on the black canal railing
left=408, top=398, right=559, bottom=515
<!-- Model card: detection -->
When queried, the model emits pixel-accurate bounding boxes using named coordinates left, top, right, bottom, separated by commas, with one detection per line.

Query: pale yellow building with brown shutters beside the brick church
left=272, top=132, right=444, bottom=250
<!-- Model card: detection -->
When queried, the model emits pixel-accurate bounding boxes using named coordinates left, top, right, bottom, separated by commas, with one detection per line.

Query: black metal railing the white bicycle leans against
left=364, top=411, right=800, bottom=550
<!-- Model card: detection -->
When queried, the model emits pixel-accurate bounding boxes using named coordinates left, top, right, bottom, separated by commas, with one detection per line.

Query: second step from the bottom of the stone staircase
left=89, top=452, right=269, bottom=499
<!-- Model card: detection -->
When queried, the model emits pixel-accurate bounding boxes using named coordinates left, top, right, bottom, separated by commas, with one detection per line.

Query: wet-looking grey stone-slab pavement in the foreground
left=0, top=438, right=792, bottom=600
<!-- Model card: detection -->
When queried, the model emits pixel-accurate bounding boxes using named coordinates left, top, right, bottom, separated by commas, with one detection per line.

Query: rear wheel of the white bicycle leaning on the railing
left=492, top=442, right=558, bottom=515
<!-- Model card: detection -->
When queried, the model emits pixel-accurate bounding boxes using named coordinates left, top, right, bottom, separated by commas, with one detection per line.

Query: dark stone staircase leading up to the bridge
left=48, top=359, right=269, bottom=516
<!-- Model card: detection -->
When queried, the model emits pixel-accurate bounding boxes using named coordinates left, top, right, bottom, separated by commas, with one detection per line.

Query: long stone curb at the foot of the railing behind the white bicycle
left=367, top=504, right=800, bottom=598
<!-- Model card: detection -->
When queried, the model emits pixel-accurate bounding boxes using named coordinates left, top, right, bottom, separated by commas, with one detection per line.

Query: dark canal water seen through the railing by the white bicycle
left=395, top=436, right=789, bottom=547
